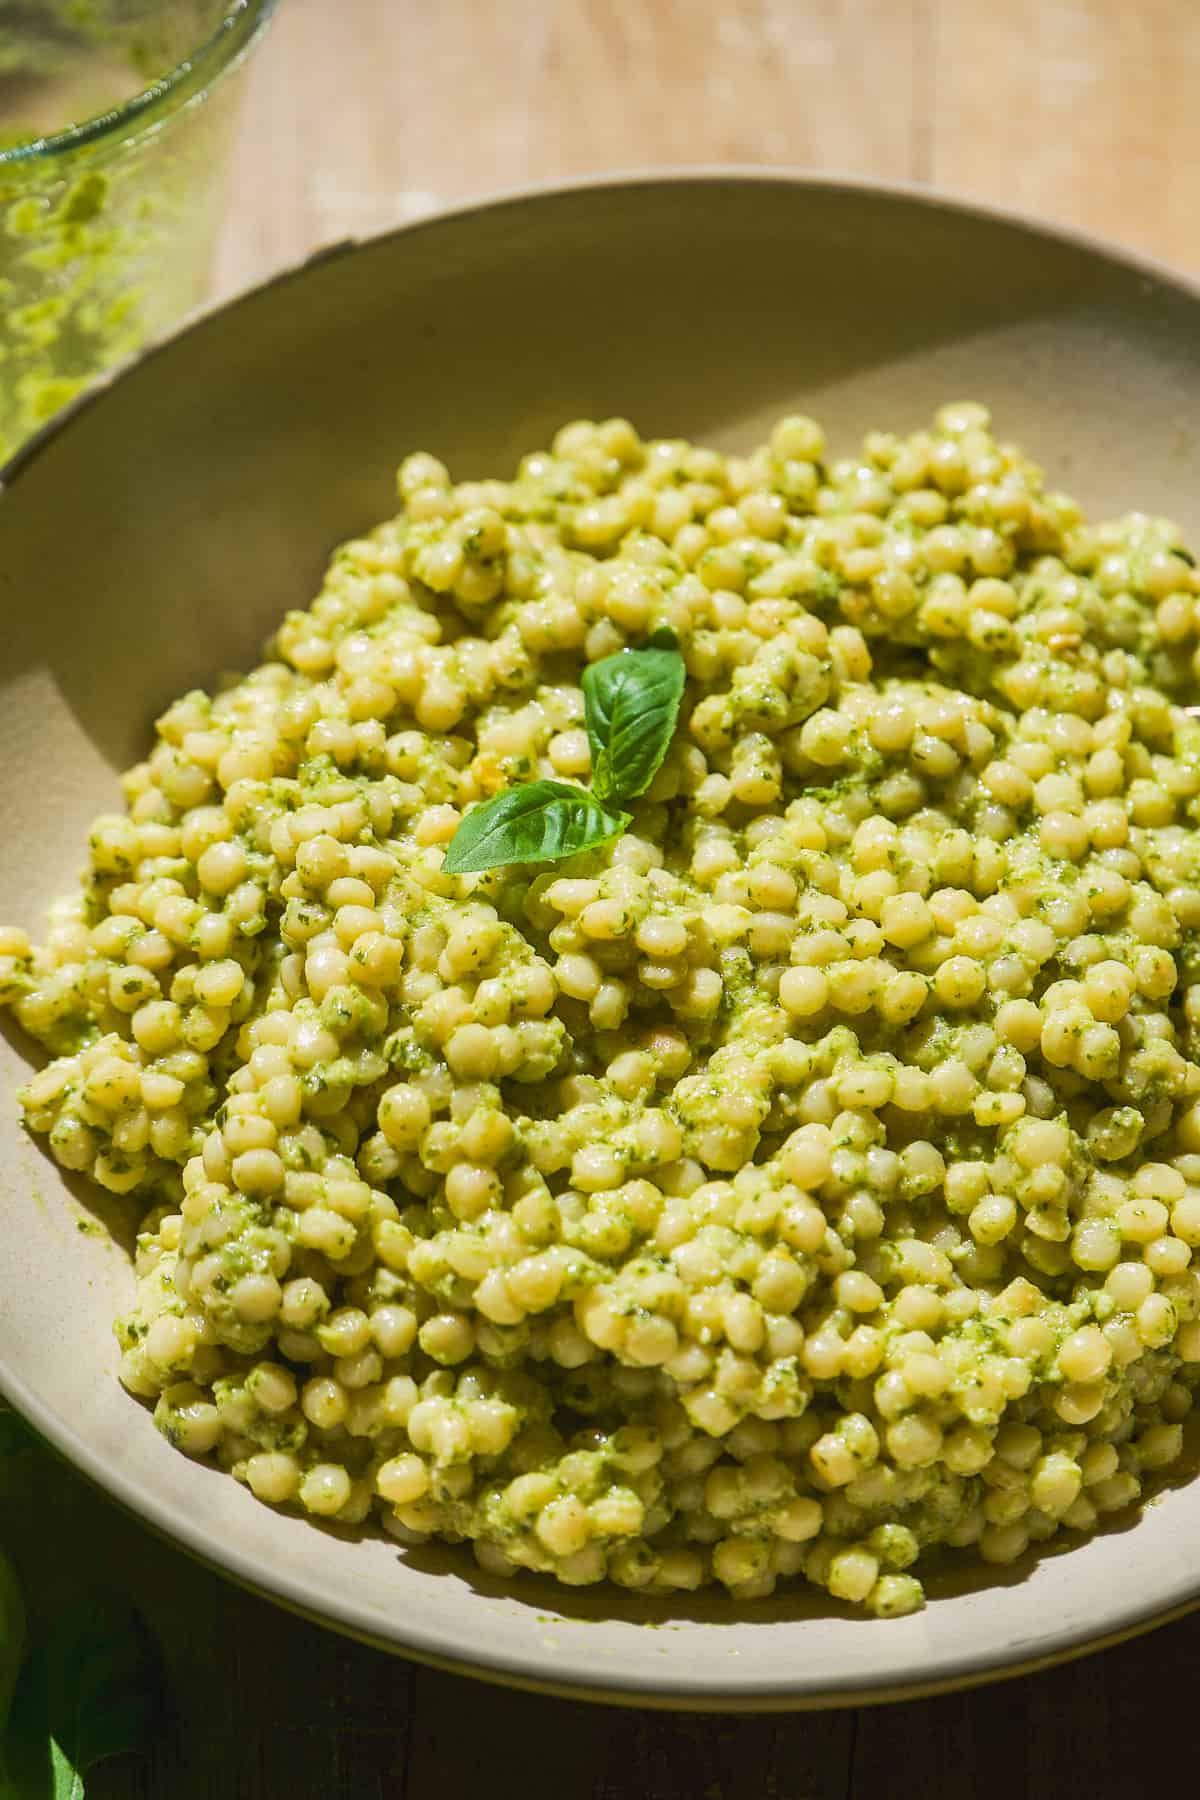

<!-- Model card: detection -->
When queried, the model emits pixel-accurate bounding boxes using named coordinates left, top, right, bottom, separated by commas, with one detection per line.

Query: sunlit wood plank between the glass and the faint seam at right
left=218, top=0, right=927, bottom=293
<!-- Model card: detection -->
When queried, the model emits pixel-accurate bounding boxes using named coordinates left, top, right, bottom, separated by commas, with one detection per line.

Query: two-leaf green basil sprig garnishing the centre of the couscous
left=443, top=644, right=687, bottom=875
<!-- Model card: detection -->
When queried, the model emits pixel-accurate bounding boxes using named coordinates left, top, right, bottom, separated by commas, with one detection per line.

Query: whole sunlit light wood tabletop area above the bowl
left=216, top=0, right=1200, bottom=293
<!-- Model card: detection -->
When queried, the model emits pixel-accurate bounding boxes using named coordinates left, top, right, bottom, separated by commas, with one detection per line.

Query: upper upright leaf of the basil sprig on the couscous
left=583, top=648, right=687, bottom=801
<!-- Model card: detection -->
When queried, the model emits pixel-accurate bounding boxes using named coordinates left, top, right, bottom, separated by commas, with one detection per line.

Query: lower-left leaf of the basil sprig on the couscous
left=443, top=781, right=630, bottom=875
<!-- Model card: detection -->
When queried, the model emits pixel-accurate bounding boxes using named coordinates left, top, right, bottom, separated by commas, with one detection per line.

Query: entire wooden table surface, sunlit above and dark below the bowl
left=21, top=0, right=1200, bottom=1800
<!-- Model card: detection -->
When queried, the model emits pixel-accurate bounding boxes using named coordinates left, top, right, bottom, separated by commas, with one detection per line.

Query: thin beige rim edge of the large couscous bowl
left=0, top=164, right=1200, bottom=1712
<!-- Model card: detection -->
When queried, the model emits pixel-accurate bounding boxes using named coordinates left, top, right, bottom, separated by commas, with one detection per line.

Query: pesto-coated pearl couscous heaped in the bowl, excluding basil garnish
left=0, top=403, right=1200, bottom=1616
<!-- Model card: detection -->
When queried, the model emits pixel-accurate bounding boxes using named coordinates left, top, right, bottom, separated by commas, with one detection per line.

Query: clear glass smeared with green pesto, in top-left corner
left=0, top=0, right=273, bottom=461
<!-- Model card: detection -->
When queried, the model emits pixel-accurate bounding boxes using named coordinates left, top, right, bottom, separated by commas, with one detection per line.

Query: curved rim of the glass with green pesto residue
left=0, top=0, right=275, bottom=171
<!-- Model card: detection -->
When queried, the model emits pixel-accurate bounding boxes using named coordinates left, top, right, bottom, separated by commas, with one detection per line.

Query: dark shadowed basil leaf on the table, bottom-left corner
left=5, top=1593, right=162, bottom=1800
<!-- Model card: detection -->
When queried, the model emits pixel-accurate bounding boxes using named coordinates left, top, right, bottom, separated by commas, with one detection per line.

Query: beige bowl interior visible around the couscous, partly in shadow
left=0, top=176, right=1200, bottom=1706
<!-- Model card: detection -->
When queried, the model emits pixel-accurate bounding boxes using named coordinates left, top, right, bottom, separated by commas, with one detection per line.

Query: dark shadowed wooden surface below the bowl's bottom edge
left=0, top=1456, right=1200, bottom=1800
